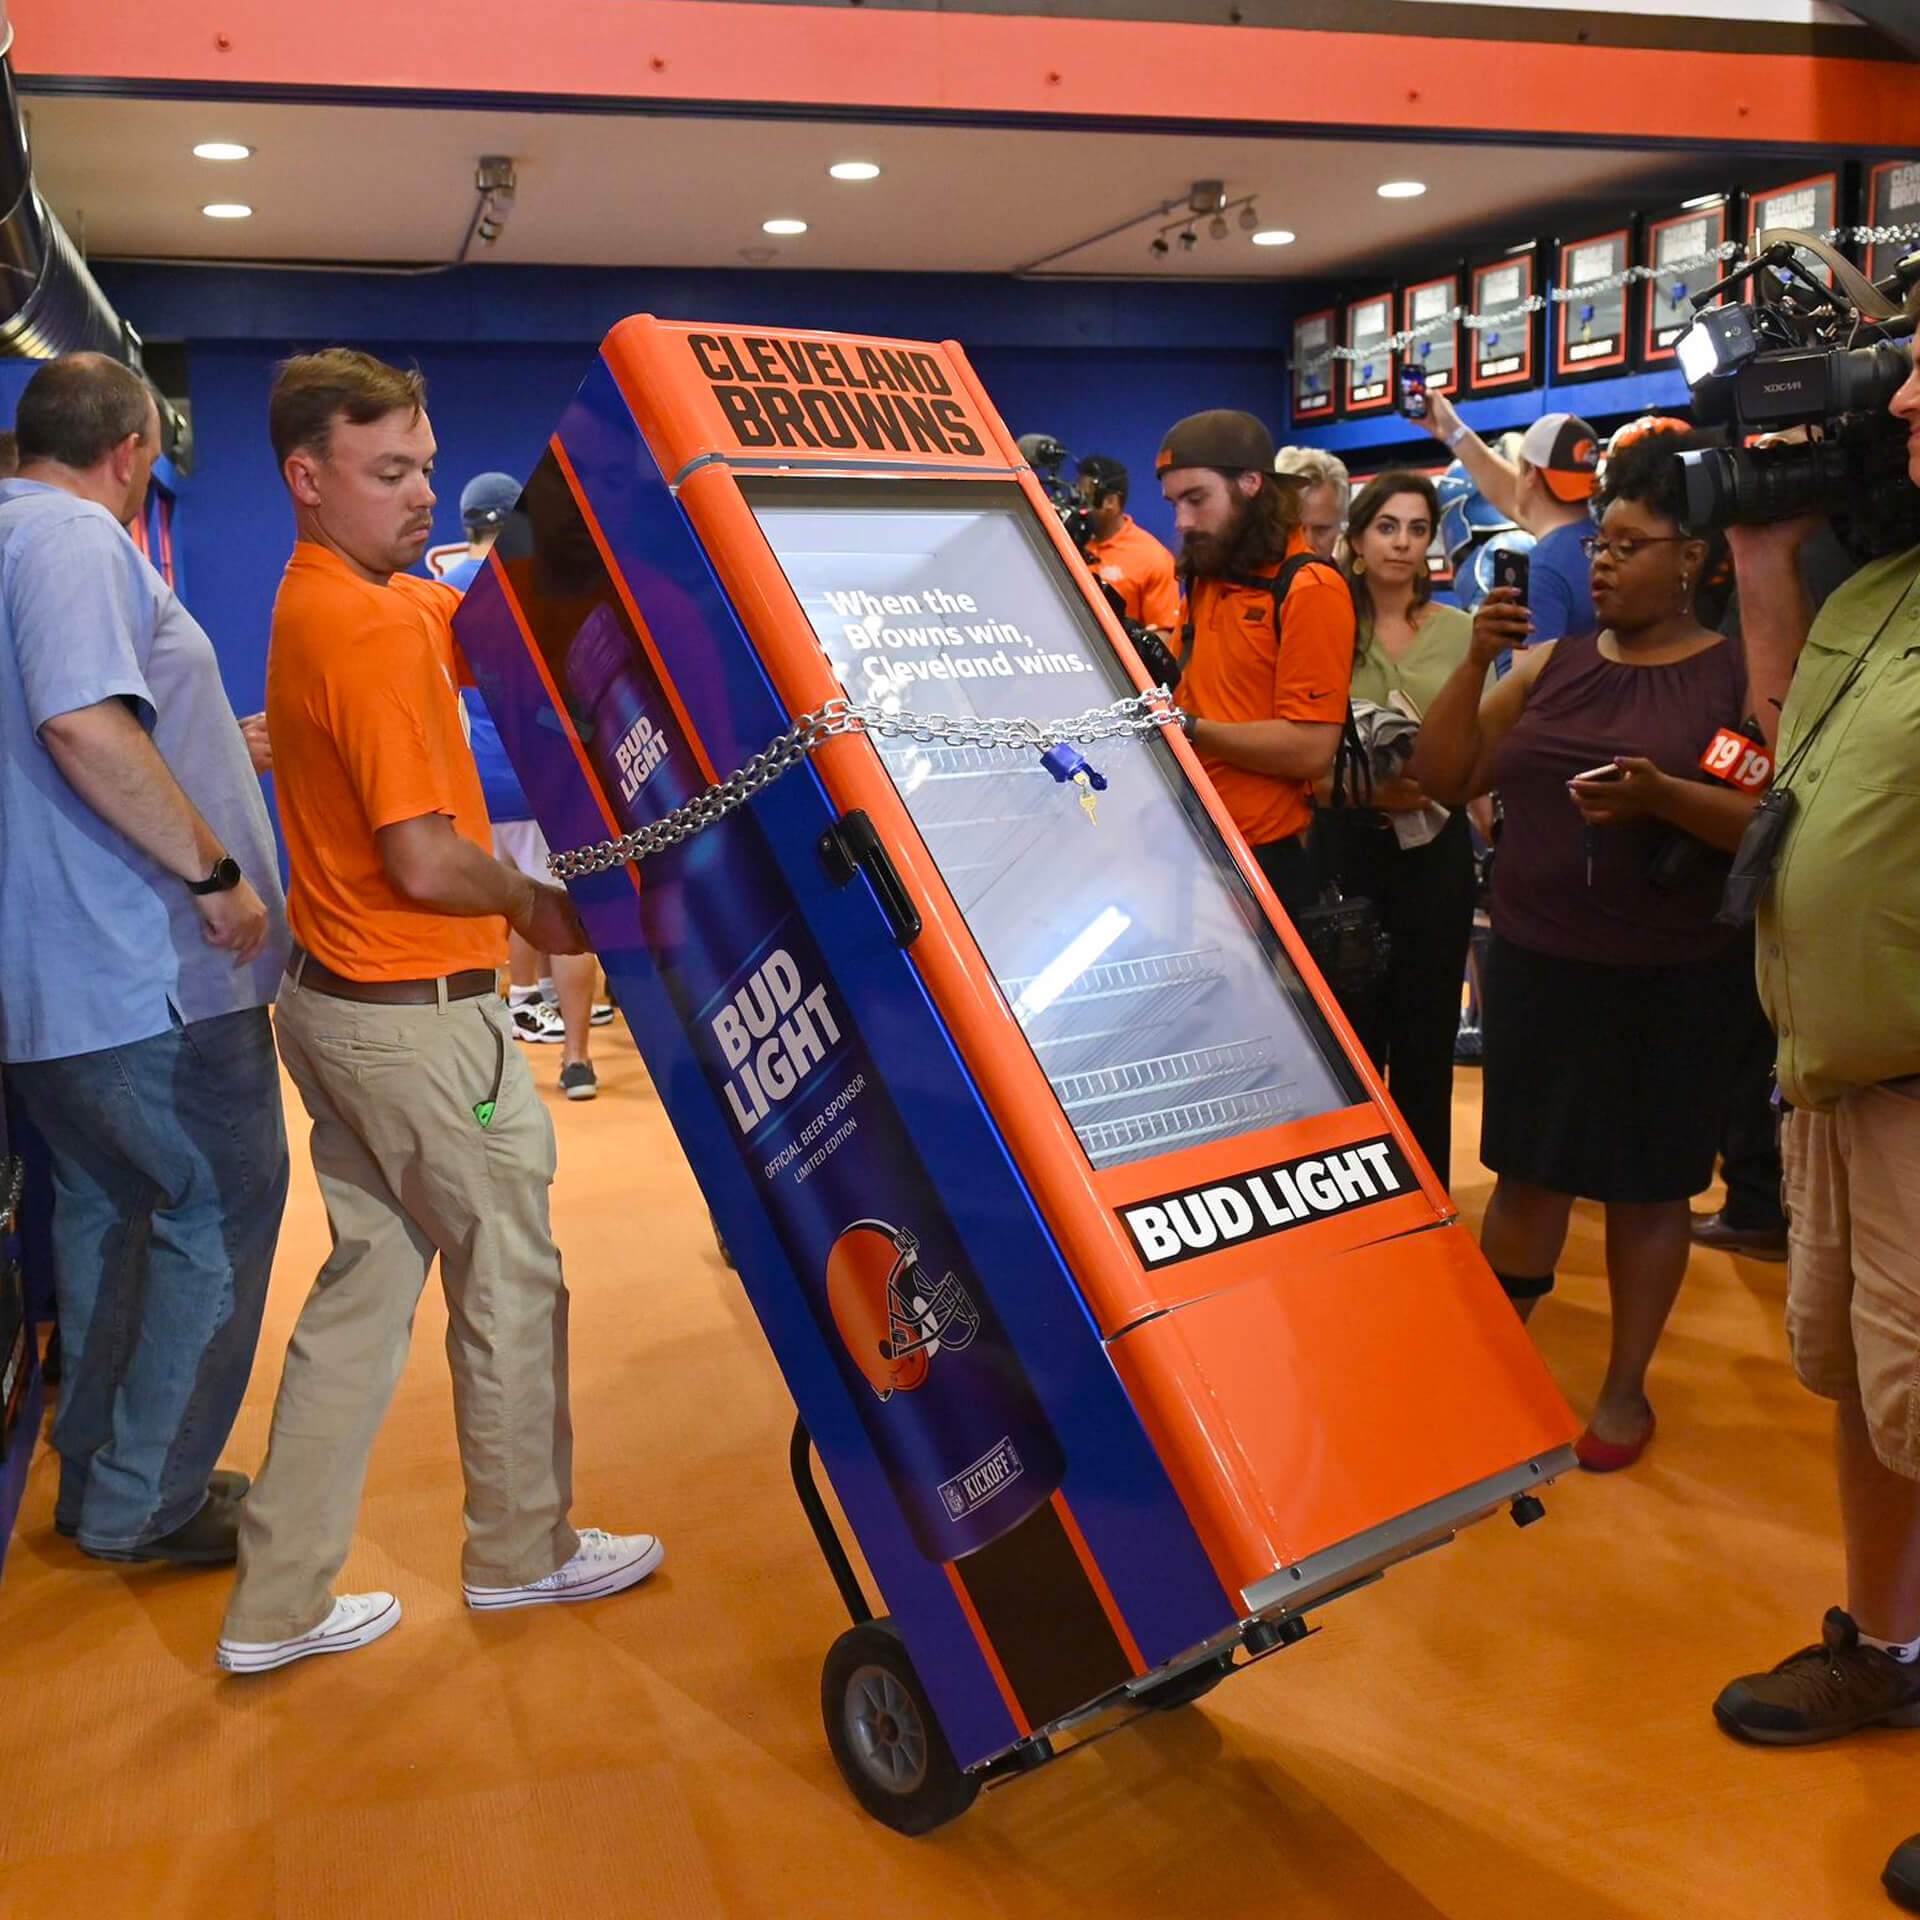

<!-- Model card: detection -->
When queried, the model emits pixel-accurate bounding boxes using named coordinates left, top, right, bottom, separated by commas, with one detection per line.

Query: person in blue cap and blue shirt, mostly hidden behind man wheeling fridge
left=440, top=474, right=612, bottom=1100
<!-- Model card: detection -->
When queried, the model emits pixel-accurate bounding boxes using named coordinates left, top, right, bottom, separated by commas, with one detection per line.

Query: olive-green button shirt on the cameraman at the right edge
left=1759, top=547, right=1920, bottom=1108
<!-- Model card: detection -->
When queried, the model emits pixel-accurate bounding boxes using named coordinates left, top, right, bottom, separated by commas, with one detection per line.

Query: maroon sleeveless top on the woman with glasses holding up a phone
left=1492, top=634, right=1747, bottom=966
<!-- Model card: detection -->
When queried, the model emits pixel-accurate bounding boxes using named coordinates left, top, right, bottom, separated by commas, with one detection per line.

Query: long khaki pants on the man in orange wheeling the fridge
left=223, top=977, right=578, bottom=1640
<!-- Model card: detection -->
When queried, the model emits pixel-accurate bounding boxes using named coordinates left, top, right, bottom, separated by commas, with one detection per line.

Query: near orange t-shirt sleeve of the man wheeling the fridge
left=326, top=620, right=467, bottom=833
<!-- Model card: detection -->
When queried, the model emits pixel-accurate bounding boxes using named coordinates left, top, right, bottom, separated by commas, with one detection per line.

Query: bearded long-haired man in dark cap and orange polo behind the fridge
left=1154, top=409, right=1356, bottom=918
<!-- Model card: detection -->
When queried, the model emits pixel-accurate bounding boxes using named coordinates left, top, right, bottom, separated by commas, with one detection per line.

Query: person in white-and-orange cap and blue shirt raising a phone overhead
left=1427, top=394, right=1599, bottom=645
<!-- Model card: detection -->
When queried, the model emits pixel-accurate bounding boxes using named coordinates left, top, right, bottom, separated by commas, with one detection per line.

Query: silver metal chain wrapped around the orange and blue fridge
left=547, top=687, right=1181, bottom=879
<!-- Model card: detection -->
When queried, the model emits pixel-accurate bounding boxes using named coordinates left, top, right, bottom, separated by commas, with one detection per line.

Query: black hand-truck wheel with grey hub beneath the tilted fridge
left=820, top=1619, right=979, bottom=1834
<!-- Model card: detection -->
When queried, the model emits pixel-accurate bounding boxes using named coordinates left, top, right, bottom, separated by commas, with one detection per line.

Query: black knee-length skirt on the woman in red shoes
left=1480, top=933, right=1753, bottom=1202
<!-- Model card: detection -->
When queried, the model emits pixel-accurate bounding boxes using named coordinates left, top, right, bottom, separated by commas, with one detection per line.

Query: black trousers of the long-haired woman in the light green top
left=1319, top=810, right=1473, bottom=1185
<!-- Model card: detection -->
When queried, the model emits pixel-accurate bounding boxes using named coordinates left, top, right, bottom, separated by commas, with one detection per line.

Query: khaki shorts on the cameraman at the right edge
left=1780, top=1081, right=1920, bottom=1480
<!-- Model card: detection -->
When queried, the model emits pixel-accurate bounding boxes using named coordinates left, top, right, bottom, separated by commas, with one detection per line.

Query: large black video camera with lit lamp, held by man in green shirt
left=1674, top=227, right=1920, bottom=559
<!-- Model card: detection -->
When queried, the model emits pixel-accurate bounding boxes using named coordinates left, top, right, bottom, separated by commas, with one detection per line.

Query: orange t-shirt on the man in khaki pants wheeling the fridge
left=267, top=540, right=507, bottom=979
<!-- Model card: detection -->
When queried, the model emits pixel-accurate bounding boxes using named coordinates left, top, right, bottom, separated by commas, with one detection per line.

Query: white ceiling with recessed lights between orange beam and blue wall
left=25, top=96, right=1728, bottom=278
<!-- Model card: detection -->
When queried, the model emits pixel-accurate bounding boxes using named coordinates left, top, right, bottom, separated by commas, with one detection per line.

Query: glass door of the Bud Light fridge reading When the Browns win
left=743, top=480, right=1365, bottom=1167
